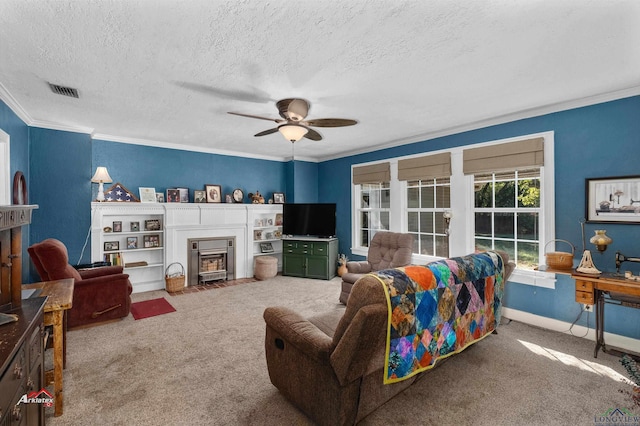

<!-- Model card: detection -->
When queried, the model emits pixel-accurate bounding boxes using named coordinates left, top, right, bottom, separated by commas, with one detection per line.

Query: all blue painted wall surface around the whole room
left=0, top=96, right=640, bottom=339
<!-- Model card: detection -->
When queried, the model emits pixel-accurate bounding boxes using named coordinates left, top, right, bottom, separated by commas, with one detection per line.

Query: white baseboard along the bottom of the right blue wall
left=502, top=307, right=640, bottom=353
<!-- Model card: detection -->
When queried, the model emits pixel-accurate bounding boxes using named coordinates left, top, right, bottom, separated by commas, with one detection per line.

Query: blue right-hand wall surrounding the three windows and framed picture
left=318, top=96, right=640, bottom=339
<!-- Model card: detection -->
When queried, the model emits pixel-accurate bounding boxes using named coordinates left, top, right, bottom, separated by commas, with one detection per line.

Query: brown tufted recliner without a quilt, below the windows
left=340, top=232, right=413, bottom=305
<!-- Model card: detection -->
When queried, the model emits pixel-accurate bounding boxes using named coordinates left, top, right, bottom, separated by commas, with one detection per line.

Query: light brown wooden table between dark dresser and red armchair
left=22, top=278, right=74, bottom=417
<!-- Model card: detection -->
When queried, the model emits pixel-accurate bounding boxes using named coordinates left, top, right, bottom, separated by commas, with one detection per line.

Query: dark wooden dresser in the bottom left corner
left=0, top=297, right=47, bottom=426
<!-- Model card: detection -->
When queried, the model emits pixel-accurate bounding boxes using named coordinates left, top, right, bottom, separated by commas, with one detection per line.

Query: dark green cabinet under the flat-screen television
left=282, top=237, right=338, bottom=280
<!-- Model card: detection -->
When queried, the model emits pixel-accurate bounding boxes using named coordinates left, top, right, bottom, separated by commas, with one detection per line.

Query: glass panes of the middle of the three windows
left=406, top=178, right=451, bottom=257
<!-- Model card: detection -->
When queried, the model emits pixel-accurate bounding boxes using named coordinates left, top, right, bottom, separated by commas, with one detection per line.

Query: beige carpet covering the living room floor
left=47, top=276, right=640, bottom=426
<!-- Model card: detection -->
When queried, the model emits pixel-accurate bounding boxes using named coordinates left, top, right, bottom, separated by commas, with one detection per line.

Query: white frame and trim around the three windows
left=351, top=131, right=556, bottom=289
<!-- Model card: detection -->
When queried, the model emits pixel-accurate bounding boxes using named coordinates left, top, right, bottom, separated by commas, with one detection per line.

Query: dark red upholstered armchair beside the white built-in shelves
left=27, top=238, right=132, bottom=328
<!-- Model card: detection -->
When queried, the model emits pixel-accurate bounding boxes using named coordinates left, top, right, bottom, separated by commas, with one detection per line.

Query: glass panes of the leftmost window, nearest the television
left=356, top=182, right=391, bottom=247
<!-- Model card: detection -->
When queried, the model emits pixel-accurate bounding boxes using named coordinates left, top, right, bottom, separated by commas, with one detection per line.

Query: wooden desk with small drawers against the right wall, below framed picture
left=571, top=272, right=640, bottom=358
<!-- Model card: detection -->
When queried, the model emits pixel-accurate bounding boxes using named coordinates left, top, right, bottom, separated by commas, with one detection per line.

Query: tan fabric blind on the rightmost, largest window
left=462, top=138, right=544, bottom=175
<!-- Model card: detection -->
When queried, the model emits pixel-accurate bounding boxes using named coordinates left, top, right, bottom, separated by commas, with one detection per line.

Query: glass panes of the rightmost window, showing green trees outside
left=473, top=168, right=541, bottom=270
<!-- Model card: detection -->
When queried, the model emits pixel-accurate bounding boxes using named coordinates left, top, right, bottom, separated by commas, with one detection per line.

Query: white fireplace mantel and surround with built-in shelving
left=91, top=202, right=282, bottom=292
